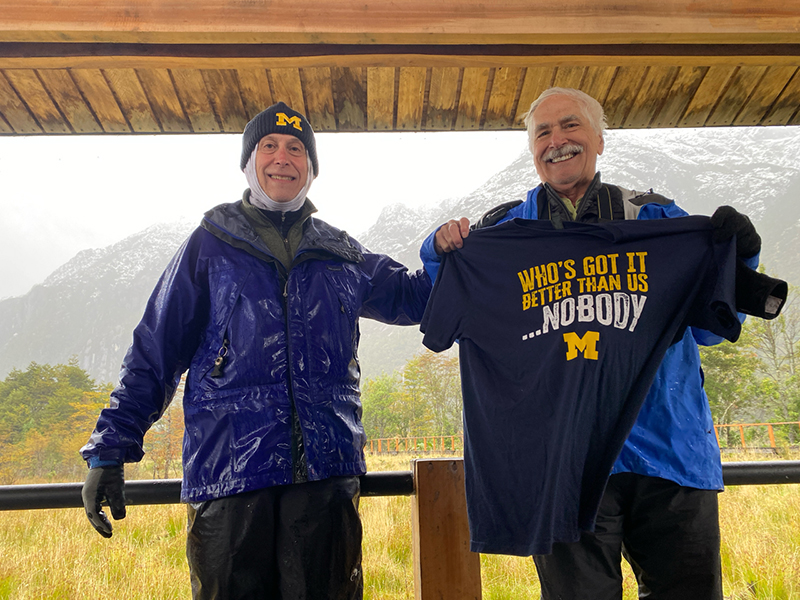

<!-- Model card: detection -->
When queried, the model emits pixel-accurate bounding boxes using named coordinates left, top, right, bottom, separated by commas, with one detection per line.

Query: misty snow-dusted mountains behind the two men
left=0, top=128, right=800, bottom=382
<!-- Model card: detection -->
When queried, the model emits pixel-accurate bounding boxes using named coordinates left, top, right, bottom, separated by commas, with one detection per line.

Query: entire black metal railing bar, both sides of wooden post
left=0, top=460, right=800, bottom=510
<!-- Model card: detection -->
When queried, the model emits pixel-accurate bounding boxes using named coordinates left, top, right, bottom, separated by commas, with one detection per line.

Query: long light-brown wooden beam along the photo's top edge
left=3, top=0, right=800, bottom=43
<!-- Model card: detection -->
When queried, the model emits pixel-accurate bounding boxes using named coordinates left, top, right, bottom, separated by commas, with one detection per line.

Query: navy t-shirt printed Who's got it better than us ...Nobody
left=421, top=217, right=740, bottom=556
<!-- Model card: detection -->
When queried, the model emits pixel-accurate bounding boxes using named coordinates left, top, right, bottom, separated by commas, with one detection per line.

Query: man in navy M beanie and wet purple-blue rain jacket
left=81, top=103, right=431, bottom=600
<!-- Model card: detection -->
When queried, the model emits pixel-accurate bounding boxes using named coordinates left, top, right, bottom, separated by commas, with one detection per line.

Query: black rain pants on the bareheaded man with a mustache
left=533, top=473, right=722, bottom=600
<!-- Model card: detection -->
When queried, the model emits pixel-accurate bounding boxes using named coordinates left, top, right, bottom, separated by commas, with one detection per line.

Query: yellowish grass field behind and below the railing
left=0, top=455, right=800, bottom=600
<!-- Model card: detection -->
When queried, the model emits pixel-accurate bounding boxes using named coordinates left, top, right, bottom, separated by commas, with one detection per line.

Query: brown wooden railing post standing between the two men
left=411, top=458, right=481, bottom=600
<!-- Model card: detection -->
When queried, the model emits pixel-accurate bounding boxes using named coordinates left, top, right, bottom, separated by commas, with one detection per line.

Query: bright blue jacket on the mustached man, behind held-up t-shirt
left=420, top=185, right=758, bottom=490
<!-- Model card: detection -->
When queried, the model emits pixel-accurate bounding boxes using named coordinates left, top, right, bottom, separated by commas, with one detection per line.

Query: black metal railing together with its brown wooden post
left=0, top=457, right=800, bottom=600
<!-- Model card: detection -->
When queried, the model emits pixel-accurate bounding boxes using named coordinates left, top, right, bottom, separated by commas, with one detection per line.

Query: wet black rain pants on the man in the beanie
left=186, top=477, right=363, bottom=600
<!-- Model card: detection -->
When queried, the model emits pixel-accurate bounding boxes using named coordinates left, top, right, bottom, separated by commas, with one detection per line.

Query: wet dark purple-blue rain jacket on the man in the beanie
left=81, top=202, right=432, bottom=502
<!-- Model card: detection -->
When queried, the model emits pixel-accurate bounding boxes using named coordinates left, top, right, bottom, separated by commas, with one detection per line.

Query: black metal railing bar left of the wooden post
left=0, top=471, right=414, bottom=510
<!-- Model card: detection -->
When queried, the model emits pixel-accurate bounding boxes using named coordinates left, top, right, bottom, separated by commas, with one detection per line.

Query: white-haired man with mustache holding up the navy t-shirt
left=421, top=88, right=761, bottom=600
